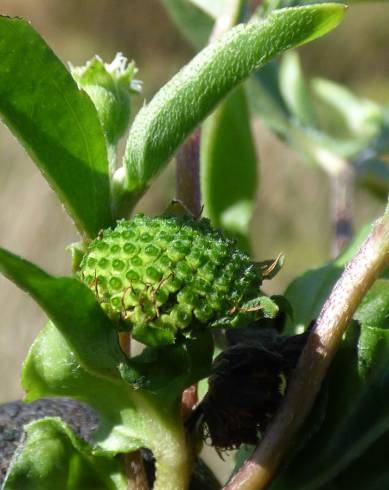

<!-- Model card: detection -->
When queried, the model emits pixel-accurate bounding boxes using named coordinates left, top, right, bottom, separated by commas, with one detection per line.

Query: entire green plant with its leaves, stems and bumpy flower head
left=0, top=0, right=389, bottom=490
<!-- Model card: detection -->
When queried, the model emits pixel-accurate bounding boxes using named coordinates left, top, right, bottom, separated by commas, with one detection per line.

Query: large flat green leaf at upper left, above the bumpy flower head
left=0, top=17, right=112, bottom=237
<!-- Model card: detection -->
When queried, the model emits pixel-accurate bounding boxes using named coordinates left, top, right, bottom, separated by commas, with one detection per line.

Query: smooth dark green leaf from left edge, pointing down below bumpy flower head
left=0, top=248, right=124, bottom=378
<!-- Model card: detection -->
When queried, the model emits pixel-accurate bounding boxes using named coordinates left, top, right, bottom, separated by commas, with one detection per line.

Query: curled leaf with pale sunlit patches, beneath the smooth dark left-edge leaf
left=22, top=323, right=171, bottom=454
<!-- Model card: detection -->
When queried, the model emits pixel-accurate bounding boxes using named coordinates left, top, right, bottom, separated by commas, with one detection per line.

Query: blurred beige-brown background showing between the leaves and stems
left=0, top=0, right=389, bottom=408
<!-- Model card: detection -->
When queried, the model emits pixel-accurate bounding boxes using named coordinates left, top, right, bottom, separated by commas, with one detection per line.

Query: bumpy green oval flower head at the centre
left=81, top=215, right=277, bottom=345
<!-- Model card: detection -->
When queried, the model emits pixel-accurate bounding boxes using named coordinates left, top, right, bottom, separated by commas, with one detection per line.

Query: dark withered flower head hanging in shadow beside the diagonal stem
left=187, top=331, right=306, bottom=450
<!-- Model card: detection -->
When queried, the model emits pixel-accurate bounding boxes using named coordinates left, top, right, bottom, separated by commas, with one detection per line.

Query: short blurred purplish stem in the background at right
left=330, top=165, right=353, bottom=257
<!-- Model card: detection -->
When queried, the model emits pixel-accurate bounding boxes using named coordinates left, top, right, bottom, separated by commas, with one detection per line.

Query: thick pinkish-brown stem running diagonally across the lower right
left=225, top=206, right=389, bottom=490
